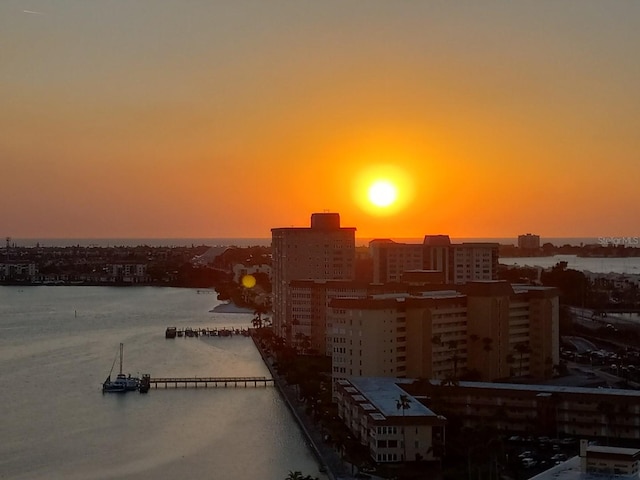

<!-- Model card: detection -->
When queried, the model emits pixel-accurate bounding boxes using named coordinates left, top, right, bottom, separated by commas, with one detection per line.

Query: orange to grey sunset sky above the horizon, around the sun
left=0, top=0, right=640, bottom=238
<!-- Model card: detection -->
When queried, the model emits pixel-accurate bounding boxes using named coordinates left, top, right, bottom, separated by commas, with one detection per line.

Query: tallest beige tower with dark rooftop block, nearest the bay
left=271, top=213, right=356, bottom=341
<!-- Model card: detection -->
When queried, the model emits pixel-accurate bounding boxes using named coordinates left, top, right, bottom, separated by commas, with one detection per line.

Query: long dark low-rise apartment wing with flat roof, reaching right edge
left=408, top=380, right=640, bottom=440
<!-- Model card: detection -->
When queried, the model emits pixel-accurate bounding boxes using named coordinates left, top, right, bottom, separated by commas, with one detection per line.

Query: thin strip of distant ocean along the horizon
left=11, top=237, right=598, bottom=247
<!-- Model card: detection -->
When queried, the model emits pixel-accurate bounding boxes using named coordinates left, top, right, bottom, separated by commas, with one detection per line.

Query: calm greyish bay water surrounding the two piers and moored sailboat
left=0, top=287, right=324, bottom=480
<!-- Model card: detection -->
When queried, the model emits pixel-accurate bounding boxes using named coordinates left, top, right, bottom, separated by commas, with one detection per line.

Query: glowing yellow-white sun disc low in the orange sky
left=353, top=165, right=413, bottom=215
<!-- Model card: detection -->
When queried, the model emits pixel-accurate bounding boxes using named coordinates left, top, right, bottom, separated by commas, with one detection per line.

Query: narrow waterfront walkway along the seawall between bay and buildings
left=251, top=336, right=360, bottom=480
